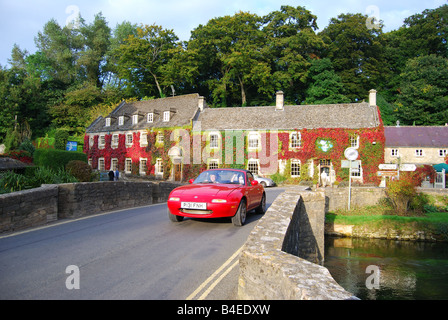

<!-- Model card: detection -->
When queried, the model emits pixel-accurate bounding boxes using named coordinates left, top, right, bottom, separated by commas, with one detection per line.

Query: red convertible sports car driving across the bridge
left=168, top=169, right=266, bottom=226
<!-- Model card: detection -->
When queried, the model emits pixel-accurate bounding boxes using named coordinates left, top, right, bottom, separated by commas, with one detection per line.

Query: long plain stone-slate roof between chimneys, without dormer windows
left=198, top=102, right=379, bottom=130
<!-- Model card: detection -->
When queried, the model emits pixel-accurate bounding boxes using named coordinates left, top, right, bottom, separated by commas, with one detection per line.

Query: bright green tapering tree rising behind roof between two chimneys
left=305, top=58, right=350, bottom=104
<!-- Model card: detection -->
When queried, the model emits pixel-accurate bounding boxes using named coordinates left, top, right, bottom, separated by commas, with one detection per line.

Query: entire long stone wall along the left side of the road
left=0, top=181, right=179, bottom=233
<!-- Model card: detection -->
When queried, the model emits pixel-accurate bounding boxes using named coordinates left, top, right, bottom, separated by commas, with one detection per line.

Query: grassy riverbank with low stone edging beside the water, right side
left=325, top=204, right=448, bottom=242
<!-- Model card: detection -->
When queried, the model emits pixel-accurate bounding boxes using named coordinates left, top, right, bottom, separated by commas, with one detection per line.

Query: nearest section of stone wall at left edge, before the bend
left=0, top=185, right=58, bottom=233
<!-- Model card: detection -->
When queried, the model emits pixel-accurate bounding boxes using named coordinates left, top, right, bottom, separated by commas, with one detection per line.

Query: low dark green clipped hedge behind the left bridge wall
left=33, top=149, right=87, bottom=170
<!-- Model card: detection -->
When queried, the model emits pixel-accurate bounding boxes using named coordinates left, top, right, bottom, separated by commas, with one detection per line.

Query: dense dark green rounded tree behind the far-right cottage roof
left=396, top=55, right=448, bottom=125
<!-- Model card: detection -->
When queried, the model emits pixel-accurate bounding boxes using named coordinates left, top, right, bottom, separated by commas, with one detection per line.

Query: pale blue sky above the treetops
left=0, top=0, right=448, bottom=66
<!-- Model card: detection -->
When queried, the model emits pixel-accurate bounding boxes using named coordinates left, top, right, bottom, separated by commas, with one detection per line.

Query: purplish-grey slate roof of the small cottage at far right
left=384, top=126, right=448, bottom=148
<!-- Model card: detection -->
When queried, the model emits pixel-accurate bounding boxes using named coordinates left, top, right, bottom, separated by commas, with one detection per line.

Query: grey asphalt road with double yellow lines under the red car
left=0, top=188, right=283, bottom=300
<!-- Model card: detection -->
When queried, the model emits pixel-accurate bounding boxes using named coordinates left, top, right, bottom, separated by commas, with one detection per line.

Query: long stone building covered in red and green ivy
left=84, top=90, right=384, bottom=184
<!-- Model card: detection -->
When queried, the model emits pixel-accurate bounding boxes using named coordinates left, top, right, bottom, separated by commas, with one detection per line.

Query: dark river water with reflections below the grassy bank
left=324, top=237, right=448, bottom=300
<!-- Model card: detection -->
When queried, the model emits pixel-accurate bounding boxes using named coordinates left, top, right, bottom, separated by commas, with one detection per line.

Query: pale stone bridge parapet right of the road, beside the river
left=238, top=191, right=354, bottom=300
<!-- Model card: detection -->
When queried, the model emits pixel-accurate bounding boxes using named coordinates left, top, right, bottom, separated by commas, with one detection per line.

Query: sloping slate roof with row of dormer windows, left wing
left=86, top=93, right=199, bottom=133
